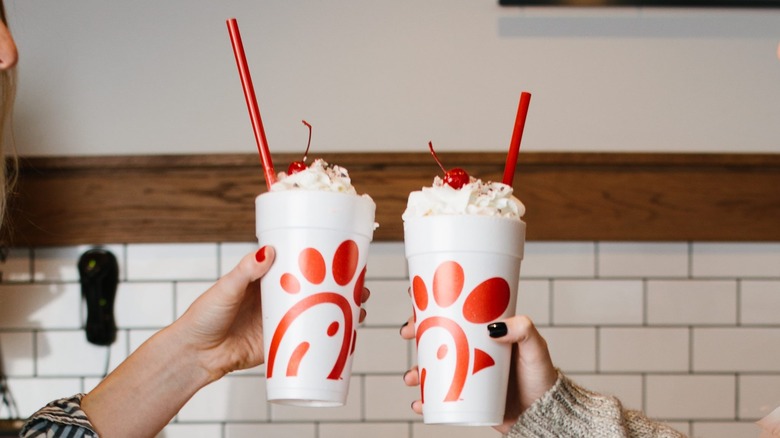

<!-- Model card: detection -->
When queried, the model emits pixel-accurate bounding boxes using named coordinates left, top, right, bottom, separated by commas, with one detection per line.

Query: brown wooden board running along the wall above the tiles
left=4, top=153, right=780, bottom=246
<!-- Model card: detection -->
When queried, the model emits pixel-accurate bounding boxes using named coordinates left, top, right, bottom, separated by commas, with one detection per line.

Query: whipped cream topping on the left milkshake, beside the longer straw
left=271, top=158, right=357, bottom=195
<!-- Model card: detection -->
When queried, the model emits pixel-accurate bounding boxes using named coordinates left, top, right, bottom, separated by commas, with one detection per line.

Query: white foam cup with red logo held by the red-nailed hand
left=255, top=190, right=376, bottom=406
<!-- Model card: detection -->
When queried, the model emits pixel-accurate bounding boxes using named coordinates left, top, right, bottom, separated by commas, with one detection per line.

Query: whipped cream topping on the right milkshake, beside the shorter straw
left=401, top=176, right=525, bottom=220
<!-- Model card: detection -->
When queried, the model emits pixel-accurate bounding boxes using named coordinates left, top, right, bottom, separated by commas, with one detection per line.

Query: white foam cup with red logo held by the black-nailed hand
left=404, top=215, right=525, bottom=426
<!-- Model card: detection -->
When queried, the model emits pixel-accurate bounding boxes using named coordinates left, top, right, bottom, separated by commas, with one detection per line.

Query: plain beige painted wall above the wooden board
left=6, top=0, right=780, bottom=155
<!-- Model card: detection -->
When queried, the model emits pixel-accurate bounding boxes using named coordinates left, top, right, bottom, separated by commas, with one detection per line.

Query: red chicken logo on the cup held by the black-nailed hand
left=412, top=261, right=511, bottom=403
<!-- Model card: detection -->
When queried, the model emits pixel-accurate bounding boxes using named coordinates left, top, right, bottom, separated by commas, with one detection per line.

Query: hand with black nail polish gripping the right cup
left=401, top=316, right=558, bottom=434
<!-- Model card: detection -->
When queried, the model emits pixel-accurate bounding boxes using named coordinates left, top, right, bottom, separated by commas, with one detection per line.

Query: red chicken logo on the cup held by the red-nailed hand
left=266, top=240, right=366, bottom=380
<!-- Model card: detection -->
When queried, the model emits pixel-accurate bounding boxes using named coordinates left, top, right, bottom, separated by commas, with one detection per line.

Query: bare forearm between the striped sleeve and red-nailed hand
left=82, top=324, right=213, bottom=438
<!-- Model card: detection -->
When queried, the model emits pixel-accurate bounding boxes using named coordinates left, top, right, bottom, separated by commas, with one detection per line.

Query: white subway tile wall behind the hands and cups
left=0, top=242, right=780, bottom=438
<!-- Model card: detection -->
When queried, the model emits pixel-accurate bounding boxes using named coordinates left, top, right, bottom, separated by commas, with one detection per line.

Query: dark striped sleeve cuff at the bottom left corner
left=19, top=394, right=98, bottom=438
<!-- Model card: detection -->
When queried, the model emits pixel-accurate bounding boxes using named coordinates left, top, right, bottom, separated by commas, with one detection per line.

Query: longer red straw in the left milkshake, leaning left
left=227, top=18, right=276, bottom=189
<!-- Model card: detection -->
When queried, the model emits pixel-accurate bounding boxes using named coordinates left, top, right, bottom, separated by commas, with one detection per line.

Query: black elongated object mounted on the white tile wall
left=78, top=248, right=119, bottom=345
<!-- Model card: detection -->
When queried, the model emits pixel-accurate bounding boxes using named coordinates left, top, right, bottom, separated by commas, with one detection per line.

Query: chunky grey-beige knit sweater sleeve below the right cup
left=506, top=374, right=685, bottom=438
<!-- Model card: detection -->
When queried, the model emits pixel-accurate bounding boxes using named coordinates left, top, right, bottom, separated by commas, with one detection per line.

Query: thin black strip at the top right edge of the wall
left=498, top=0, right=780, bottom=9
